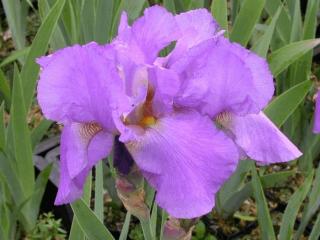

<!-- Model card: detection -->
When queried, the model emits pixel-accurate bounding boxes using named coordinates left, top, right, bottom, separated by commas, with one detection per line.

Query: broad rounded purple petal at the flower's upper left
left=38, top=43, right=121, bottom=129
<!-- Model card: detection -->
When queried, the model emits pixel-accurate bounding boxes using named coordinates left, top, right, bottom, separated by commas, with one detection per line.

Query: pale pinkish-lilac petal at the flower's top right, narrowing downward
left=168, top=9, right=219, bottom=65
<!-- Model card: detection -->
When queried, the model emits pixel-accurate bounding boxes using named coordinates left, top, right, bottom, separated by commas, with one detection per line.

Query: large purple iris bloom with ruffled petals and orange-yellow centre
left=38, top=6, right=301, bottom=218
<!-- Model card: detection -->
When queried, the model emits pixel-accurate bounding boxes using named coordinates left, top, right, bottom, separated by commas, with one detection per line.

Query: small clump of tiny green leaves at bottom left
left=26, top=212, right=66, bottom=240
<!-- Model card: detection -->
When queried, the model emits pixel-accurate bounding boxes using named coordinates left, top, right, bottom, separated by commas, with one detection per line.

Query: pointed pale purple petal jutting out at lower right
left=228, top=112, right=302, bottom=164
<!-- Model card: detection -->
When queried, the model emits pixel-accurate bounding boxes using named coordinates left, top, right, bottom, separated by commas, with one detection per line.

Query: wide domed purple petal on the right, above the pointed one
left=172, top=37, right=274, bottom=117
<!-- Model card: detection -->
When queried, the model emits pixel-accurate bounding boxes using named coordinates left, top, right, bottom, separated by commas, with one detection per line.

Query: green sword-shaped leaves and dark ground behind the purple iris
left=0, top=0, right=320, bottom=240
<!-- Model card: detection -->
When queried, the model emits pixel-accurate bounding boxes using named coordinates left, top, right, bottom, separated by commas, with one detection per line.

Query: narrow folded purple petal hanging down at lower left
left=55, top=123, right=113, bottom=205
